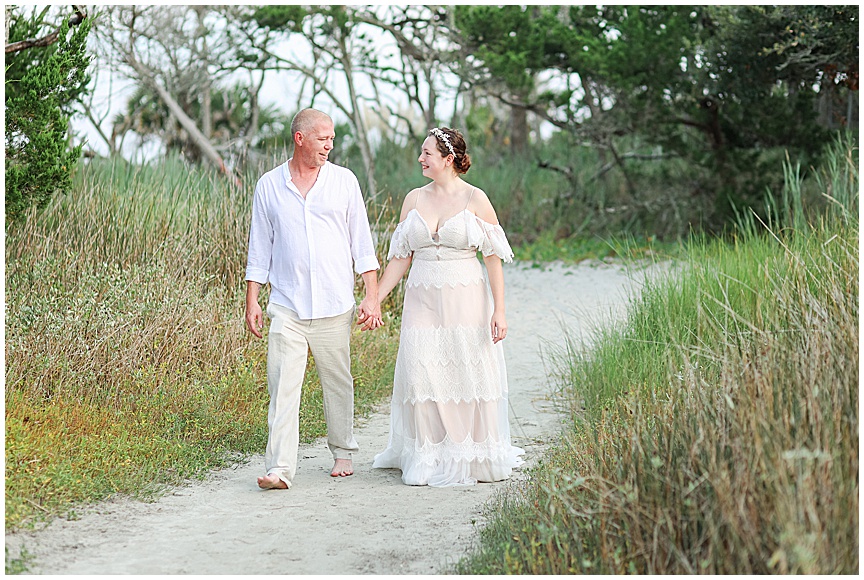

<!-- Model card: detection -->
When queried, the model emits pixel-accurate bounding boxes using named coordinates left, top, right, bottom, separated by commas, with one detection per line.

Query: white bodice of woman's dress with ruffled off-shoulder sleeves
left=387, top=209, right=513, bottom=262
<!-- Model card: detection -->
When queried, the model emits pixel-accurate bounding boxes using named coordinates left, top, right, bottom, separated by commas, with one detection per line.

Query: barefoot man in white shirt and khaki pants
left=246, top=109, right=382, bottom=489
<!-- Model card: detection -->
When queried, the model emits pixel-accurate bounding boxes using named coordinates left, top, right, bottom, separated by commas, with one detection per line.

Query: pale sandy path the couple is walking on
left=6, top=263, right=660, bottom=574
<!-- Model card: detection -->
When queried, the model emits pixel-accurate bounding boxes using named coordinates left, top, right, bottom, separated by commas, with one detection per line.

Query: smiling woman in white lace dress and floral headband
left=372, top=127, right=523, bottom=487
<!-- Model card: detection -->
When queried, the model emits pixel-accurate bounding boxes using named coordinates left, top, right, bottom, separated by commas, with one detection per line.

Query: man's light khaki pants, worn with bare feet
left=264, top=304, right=359, bottom=487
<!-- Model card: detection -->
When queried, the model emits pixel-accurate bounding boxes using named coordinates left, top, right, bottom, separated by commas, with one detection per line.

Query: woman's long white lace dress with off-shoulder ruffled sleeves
left=373, top=209, right=523, bottom=487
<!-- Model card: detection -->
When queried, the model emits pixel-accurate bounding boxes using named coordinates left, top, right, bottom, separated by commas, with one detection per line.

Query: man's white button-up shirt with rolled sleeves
left=246, top=161, right=379, bottom=320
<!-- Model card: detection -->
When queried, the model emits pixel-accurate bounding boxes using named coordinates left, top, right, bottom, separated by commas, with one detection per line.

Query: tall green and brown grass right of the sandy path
left=455, top=134, right=859, bottom=574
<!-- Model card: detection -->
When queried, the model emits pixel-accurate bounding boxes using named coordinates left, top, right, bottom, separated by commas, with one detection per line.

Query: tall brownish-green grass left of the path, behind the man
left=5, top=159, right=398, bottom=529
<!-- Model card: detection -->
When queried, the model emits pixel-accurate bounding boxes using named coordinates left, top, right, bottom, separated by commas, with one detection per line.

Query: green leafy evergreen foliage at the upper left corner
left=4, top=9, right=90, bottom=223
